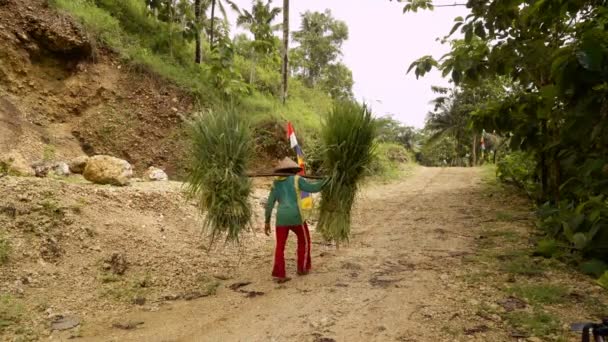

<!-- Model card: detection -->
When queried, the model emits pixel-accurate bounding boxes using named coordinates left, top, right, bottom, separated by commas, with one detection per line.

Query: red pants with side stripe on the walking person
left=272, top=223, right=310, bottom=278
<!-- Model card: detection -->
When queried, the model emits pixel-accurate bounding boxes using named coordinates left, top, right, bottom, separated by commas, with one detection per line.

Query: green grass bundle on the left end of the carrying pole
left=187, top=108, right=253, bottom=243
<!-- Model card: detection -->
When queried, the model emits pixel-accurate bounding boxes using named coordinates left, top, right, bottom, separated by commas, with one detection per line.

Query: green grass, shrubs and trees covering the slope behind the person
left=51, top=0, right=412, bottom=179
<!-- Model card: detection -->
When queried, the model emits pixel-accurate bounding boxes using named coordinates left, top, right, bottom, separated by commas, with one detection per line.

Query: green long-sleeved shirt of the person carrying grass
left=266, top=176, right=327, bottom=226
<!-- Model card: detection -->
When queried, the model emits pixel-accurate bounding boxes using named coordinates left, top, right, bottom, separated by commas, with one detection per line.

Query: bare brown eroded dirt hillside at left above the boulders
left=0, top=0, right=193, bottom=177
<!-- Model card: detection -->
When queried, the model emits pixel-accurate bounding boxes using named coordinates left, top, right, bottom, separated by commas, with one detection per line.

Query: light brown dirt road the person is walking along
left=75, top=168, right=524, bottom=341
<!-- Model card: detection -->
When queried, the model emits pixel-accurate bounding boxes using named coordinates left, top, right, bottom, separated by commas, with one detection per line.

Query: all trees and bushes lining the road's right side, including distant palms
left=404, top=0, right=608, bottom=287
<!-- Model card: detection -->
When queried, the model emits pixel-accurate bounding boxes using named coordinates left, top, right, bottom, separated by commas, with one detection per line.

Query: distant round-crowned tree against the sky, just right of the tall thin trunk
left=293, top=10, right=348, bottom=87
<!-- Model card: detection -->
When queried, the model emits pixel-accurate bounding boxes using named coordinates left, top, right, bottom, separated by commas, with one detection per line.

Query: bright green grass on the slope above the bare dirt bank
left=51, top=0, right=332, bottom=135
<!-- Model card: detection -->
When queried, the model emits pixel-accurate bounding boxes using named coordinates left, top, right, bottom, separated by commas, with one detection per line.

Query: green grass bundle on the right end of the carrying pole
left=317, top=102, right=376, bottom=244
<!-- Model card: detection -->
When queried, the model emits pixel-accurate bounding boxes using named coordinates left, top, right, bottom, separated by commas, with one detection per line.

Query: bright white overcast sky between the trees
left=226, top=0, right=468, bottom=128
